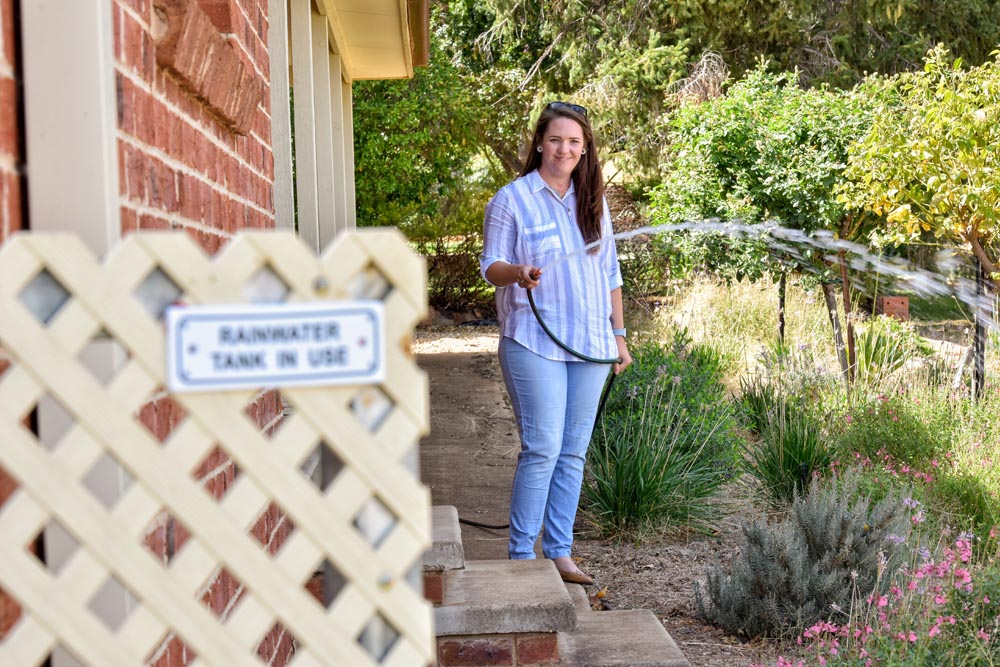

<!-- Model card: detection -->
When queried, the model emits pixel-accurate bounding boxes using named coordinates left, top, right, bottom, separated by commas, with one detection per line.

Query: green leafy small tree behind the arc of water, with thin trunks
left=651, top=64, right=871, bottom=373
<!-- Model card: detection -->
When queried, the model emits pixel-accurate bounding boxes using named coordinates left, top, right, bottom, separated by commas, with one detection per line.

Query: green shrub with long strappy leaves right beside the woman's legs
left=583, top=331, right=737, bottom=535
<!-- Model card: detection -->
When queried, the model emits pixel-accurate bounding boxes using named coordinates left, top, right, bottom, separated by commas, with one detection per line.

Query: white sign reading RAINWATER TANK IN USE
left=167, top=301, right=385, bottom=392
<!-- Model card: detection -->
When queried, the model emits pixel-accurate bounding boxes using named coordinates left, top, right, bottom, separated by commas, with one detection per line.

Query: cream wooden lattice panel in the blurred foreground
left=0, top=230, right=434, bottom=667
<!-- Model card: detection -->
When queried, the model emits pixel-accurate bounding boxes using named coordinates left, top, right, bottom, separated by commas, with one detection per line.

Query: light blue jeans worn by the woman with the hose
left=499, top=338, right=611, bottom=560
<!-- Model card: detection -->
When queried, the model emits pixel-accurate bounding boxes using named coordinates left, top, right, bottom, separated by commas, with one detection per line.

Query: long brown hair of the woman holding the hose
left=521, top=105, right=604, bottom=251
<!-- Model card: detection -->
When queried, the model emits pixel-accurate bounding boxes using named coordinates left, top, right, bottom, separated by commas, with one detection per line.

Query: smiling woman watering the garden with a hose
left=480, top=102, right=632, bottom=584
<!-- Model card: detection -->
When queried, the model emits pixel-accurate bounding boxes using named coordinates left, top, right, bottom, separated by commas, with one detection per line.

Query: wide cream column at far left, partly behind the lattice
left=21, top=0, right=130, bottom=667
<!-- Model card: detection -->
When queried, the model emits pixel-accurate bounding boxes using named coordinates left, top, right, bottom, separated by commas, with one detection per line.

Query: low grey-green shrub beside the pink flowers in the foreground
left=695, top=474, right=908, bottom=638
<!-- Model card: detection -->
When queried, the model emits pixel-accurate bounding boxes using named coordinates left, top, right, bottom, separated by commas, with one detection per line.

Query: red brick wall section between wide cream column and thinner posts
left=109, top=0, right=274, bottom=252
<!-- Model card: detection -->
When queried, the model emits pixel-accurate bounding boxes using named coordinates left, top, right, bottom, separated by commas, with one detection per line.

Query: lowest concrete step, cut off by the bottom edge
left=557, top=612, right=691, bottom=667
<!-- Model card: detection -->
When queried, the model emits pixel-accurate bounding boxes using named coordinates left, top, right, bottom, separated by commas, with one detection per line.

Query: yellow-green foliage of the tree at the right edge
left=840, top=47, right=1000, bottom=274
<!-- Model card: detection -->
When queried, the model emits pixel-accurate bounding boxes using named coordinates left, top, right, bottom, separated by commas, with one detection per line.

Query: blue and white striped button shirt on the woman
left=479, top=171, right=622, bottom=361
